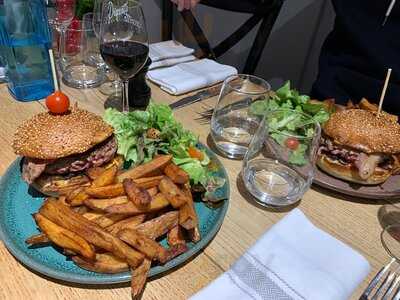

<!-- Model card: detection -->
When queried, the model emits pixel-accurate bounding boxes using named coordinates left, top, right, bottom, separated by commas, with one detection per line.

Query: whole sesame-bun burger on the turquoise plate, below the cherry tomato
left=12, top=108, right=117, bottom=196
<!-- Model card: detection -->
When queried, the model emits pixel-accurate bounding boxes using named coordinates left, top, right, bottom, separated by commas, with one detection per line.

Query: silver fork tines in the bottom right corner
left=359, top=258, right=400, bottom=300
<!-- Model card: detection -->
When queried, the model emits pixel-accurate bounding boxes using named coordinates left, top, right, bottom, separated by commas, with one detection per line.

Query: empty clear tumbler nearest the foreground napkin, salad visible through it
left=242, top=110, right=321, bottom=206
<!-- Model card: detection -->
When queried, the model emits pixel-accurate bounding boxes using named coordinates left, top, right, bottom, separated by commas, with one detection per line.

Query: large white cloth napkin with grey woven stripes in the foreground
left=191, top=209, right=370, bottom=300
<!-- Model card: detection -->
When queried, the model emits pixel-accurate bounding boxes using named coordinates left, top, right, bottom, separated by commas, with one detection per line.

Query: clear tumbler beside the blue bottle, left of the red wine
left=61, top=21, right=106, bottom=88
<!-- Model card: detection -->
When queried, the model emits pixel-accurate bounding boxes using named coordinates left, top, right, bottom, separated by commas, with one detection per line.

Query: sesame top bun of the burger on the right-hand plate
left=323, top=109, right=400, bottom=154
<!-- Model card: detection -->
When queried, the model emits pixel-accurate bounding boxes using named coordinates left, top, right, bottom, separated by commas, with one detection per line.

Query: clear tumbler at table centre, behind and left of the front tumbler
left=211, top=74, right=271, bottom=159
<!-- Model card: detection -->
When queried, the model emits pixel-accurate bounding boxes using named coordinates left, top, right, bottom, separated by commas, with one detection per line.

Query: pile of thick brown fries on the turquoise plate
left=26, top=155, right=200, bottom=298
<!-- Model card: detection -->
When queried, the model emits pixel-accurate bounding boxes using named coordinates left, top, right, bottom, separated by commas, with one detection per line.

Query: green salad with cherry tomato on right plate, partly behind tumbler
left=250, top=81, right=334, bottom=166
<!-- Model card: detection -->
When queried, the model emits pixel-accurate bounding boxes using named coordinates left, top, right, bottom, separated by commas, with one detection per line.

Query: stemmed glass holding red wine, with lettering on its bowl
left=100, top=0, right=149, bottom=112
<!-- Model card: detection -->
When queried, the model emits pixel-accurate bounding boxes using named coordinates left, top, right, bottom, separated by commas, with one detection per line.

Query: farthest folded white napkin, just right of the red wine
left=149, top=41, right=194, bottom=62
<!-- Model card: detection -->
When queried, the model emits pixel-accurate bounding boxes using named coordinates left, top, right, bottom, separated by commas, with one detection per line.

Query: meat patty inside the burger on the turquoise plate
left=22, top=136, right=117, bottom=184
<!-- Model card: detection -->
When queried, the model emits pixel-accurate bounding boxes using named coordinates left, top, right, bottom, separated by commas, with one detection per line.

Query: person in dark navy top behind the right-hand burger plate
left=311, top=0, right=400, bottom=114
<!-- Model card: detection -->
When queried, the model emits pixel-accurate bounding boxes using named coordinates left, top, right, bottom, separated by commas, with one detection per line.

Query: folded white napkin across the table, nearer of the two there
left=147, top=58, right=237, bottom=95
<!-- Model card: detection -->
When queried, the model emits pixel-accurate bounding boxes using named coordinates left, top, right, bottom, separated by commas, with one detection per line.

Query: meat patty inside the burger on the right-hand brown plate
left=318, top=137, right=393, bottom=170
